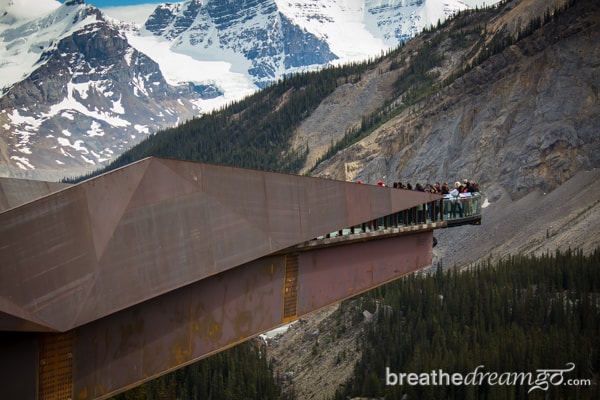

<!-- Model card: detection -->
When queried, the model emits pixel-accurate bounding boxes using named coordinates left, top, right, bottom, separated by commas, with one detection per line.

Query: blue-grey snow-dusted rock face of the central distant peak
left=144, top=0, right=338, bottom=86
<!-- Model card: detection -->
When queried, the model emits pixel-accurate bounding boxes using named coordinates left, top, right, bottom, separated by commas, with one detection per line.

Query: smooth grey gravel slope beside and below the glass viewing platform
left=434, top=169, right=600, bottom=267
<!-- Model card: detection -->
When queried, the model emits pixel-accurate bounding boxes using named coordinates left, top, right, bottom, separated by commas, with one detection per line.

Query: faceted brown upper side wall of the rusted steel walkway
left=0, top=158, right=440, bottom=331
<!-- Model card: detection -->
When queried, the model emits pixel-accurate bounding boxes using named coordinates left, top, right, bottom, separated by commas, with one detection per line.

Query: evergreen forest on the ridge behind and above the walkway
left=65, top=0, right=577, bottom=182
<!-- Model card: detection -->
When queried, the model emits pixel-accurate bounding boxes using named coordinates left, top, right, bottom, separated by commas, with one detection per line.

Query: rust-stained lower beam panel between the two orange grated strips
left=74, top=256, right=285, bottom=400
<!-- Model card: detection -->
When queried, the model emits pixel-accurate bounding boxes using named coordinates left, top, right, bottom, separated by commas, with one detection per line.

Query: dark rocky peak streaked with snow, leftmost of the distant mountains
left=0, top=1, right=201, bottom=179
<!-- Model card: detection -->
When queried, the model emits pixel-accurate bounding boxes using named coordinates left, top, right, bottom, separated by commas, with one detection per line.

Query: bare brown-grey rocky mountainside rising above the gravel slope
left=62, top=0, right=599, bottom=202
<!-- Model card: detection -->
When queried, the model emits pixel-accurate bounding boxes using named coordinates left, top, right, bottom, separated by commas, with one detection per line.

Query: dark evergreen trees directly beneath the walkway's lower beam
left=113, top=341, right=294, bottom=400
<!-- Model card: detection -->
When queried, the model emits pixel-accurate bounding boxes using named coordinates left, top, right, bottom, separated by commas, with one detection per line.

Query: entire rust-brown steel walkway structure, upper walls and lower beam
left=0, top=158, right=445, bottom=399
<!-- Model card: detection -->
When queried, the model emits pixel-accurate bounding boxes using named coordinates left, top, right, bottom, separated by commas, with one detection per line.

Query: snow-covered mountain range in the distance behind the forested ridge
left=0, top=0, right=494, bottom=178
